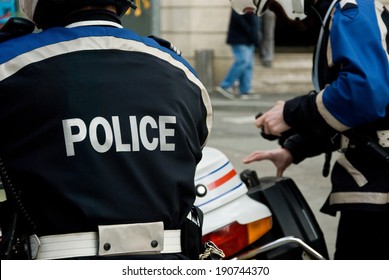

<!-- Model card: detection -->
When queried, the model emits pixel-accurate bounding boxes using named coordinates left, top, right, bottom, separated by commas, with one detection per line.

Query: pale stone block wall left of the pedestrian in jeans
left=160, top=0, right=232, bottom=82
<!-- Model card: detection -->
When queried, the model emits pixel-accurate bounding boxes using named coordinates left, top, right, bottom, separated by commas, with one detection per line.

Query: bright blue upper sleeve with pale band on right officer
left=316, top=0, right=389, bottom=131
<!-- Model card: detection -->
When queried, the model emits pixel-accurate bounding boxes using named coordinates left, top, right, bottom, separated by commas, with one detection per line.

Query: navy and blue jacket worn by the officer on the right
left=284, top=0, right=389, bottom=212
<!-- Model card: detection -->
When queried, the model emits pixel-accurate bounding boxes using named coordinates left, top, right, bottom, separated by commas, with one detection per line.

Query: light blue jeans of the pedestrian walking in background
left=220, top=45, right=255, bottom=94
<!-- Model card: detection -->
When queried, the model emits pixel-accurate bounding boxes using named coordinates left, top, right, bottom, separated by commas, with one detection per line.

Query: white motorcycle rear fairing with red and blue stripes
left=195, top=147, right=271, bottom=235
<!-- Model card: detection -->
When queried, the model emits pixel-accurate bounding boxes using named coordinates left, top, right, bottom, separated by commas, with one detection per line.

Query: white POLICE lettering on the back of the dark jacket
left=62, top=116, right=176, bottom=156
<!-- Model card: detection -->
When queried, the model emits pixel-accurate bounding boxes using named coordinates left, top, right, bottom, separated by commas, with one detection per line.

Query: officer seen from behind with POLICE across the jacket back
left=0, top=0, right=212, bottom=259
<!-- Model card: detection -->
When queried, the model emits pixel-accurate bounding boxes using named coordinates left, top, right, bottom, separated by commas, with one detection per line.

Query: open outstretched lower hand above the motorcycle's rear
left=243, top=148, right=293, bottom=177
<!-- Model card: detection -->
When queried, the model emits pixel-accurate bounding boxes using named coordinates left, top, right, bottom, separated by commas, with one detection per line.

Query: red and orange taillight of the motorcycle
left=202, top=217, right=272, bottom=258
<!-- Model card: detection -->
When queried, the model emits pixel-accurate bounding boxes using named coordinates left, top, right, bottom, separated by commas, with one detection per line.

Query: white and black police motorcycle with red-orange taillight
left=195, top=147, right=329, bottom=260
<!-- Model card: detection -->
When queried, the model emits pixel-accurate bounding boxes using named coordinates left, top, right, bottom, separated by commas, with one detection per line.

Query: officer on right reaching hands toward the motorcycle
left=232, top=0, right=389, bottom=259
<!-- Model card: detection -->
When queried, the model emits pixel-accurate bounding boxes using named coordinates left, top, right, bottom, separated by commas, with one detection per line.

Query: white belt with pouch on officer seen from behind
left=30, top=222, right=181, bottom=260
